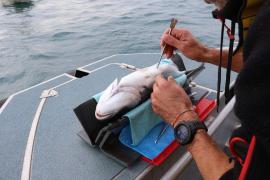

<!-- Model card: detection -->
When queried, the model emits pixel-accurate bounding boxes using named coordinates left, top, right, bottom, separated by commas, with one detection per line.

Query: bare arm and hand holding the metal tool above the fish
left=160, top=29, right=243, bottom=72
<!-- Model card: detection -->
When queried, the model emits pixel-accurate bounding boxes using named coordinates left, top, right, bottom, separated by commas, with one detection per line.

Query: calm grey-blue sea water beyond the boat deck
left=0, top=0, right=220, bottom=99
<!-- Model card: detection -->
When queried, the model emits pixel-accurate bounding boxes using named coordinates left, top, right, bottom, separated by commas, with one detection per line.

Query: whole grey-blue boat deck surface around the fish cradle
left=0, top=54, right=238, bottom=180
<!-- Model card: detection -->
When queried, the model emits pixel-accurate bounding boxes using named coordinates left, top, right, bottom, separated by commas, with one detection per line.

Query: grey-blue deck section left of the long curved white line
left=0, top=76, right=73, bottom=180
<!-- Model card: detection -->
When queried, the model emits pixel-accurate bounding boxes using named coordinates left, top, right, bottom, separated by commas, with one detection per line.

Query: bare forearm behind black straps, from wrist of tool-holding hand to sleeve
left=200, top=48, right=243, bottom=72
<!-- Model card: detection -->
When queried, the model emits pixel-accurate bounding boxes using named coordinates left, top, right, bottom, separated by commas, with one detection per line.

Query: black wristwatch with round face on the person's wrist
left=174, top=120, right=207, bottom=145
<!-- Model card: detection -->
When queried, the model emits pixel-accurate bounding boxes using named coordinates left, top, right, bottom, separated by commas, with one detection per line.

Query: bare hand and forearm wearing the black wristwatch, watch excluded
left=151, top=76, right=234, bottom=180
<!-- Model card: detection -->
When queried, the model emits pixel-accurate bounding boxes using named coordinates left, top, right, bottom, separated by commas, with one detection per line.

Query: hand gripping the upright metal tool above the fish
left=160, top=28, right=210, bottom=62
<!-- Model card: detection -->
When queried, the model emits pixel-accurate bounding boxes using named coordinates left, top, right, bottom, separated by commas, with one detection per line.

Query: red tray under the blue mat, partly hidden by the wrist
left=141, top=98, right=216, bottom=166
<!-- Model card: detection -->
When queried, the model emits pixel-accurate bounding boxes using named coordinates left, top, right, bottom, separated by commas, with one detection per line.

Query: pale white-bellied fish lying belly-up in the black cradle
left=95, top=64, right=181, bottom=120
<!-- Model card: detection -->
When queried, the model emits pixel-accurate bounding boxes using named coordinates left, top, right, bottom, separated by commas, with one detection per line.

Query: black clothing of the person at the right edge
left=222, top=0, right=270, bottom=180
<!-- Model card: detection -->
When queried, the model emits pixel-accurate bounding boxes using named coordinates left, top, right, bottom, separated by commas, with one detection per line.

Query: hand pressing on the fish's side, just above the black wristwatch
left=151, top=76, right=198, bottom=124
